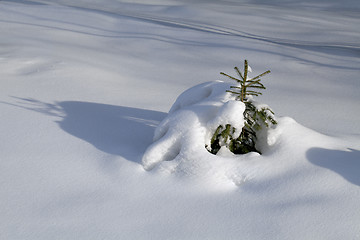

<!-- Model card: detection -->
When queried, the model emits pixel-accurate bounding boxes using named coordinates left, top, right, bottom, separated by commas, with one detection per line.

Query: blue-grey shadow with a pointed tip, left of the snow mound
left=8, top=98, right=166, bottom=163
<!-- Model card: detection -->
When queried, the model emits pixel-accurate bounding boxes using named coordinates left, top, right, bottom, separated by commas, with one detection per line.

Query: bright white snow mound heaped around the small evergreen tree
left=142, top=81, right=358, bottom=189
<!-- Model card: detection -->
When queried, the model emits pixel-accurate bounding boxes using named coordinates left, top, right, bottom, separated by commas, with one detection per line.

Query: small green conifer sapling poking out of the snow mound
left=208, top=60, right=277, bottom=154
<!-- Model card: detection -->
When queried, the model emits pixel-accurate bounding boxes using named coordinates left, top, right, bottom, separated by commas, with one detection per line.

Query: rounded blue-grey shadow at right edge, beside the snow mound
left=306, top=148, right=360, bottom=186
